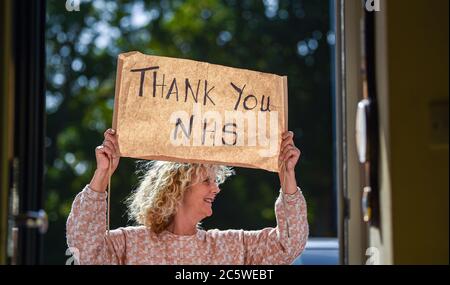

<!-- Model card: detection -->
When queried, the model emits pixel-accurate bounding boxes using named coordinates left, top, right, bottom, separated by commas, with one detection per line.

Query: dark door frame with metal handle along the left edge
left=0, top=0, right=46, bottom=264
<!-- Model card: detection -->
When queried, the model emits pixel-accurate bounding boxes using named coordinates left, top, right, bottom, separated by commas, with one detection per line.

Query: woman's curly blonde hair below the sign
left=127, top=161, right=234, bottom=234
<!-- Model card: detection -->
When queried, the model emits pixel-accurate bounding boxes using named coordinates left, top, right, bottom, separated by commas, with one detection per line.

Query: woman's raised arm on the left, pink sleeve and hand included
left=66, top=129, right=125, bottom=264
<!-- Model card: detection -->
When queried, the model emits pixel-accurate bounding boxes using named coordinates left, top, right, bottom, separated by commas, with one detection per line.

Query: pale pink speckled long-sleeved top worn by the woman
left=67, top=186, right=309, bottom=264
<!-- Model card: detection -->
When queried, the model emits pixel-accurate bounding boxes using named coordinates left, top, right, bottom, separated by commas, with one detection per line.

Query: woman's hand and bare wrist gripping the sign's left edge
left=89, top=129, right=120, bottom=192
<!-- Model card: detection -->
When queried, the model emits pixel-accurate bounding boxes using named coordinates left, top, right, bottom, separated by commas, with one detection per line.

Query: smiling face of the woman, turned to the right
left=182, top=168, right=220, bottom=221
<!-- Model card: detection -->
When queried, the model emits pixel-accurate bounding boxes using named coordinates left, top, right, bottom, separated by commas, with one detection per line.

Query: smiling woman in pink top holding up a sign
left=67, top=129, right=308, bottom=264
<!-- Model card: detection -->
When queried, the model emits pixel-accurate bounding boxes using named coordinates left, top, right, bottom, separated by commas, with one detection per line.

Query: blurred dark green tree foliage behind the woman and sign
left=45, top=0, right=336, bottom=264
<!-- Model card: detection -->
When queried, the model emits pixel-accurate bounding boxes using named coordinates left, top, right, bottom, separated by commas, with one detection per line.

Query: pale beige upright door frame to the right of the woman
left=334, top=0, right=369, bottom=264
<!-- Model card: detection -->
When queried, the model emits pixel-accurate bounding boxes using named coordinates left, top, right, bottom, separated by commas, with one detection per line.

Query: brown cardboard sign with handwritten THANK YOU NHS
left=113, top=52, right=287, bottom=172
